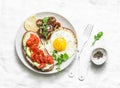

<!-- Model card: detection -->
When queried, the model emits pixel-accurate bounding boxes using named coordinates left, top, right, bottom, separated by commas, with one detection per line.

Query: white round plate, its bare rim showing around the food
left=15, top=12, right=76, bottom=74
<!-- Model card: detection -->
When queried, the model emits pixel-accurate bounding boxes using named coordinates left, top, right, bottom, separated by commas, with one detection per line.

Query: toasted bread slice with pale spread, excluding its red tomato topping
left=22, top=32, right=54, bottom=72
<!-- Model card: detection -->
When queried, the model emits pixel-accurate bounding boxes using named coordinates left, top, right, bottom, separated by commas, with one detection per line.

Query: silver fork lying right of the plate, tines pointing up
left=68, top=24, right=93, bottom=80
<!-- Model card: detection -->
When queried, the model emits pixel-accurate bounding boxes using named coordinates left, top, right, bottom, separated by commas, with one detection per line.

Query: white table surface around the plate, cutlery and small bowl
left=0, top=0, right=120, bottom=88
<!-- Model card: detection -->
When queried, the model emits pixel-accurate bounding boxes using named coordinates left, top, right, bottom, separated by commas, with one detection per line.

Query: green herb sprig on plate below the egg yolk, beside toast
left=52, top=50, right=69, bottom=71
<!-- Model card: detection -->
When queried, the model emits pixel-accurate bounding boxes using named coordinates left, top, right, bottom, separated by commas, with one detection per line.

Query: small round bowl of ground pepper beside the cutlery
left=91, top=48, right=108, bottom=65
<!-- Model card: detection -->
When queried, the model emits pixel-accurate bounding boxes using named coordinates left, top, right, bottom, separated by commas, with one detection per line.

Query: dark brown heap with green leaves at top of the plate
left=36, top=17, right=61, bottom=40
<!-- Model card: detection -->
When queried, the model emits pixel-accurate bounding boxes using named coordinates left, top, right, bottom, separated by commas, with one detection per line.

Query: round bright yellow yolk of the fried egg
left=53, top=38, right=67, bottom=51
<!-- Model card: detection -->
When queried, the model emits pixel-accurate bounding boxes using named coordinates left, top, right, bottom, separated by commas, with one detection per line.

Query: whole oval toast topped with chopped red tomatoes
left=22, top=32, right=54, bottom=71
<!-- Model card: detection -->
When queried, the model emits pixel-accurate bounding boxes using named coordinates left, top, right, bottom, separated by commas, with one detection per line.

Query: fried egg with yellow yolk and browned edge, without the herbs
left=45, top=27, right=77, bottom=57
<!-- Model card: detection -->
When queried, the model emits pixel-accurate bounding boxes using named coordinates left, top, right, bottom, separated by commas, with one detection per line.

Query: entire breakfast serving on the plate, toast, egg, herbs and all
left=22, top=16, right=77, bottom=72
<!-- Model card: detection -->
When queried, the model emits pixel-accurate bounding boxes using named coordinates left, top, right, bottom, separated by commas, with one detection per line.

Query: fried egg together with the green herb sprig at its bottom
left=45, top=27, right=77, bottom=71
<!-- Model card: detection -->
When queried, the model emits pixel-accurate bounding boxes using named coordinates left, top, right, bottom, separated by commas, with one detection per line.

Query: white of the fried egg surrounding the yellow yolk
left=45, top=27, right=77, bottom=57
